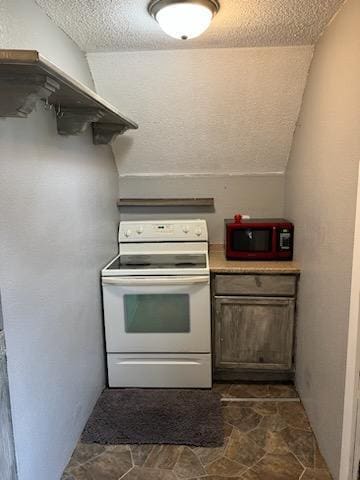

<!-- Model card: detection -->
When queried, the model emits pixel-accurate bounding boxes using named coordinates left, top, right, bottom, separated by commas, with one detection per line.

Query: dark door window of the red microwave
left=232, top=228, right=272, bottom=252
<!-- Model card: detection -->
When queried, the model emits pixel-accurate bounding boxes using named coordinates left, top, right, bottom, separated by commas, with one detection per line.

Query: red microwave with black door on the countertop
left=225, top=215, right=294, bottom=260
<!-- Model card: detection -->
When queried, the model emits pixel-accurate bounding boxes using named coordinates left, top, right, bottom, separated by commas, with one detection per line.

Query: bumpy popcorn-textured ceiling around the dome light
left=36, top=0, right=343, bottom=52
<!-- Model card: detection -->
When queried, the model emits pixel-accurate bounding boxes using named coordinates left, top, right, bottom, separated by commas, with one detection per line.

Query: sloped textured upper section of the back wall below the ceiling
left=88, top=47, right=312, bottom=175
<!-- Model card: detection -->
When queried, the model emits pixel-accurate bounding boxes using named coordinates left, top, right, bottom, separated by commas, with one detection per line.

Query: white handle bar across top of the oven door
left=102, top=275, right=209, bottom=287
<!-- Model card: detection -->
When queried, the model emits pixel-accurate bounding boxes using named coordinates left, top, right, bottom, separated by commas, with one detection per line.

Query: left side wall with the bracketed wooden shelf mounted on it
left=0, top=0, right=118, bottom=480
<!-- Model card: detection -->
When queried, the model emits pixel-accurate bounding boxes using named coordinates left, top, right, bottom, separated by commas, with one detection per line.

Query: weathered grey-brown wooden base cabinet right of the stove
left=212, top=274, right=297, bottom=381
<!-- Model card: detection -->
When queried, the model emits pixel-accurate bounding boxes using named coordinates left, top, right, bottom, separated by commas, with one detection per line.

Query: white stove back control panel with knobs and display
left=119, top=220, right=208, bottom=243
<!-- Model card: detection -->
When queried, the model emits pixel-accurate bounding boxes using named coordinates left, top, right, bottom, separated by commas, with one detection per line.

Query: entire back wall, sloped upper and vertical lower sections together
left=88, top=47, right=312, bottom=238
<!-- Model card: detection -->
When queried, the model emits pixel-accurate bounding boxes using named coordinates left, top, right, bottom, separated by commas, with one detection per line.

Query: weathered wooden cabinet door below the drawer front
left=215, top=297, right=294, bottom=370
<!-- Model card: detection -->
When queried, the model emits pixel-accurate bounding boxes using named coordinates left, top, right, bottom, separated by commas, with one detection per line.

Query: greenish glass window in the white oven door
left=124, top=294, right=190, bottom=333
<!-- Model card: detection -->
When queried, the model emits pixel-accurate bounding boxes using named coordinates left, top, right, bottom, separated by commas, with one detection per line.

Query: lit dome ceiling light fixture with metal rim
left=148, top=0, right=220, bottom=40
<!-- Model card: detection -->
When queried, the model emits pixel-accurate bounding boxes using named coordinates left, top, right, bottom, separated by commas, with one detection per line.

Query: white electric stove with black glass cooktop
left=102, top=220, right=211, bottom=388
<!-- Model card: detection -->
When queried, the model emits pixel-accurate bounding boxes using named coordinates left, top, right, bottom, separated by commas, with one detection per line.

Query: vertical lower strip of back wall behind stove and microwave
left=120, top=175, right=284, bottom=243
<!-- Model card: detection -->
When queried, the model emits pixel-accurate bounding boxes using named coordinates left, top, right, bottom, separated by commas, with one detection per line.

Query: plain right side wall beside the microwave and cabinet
left=286, top=0, right=360, bottom=479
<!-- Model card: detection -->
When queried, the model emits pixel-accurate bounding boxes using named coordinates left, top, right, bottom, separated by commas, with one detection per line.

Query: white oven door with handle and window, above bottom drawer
left=102, top=275, right=210, bottom=353
